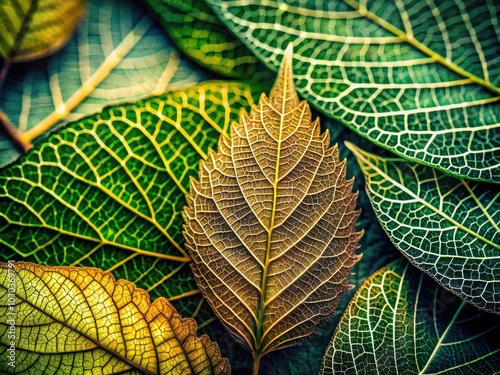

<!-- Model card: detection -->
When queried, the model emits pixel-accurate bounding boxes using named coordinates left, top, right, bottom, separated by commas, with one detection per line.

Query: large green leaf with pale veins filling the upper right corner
left=203, top=0, right=500, bottom=183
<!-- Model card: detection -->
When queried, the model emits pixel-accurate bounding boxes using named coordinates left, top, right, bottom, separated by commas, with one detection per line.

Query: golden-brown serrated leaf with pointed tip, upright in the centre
left=185, top=48, right=361, bottom=367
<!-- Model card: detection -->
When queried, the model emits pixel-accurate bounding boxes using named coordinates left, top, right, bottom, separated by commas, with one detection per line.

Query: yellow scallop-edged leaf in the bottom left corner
left=0, top=263, right=230, bottom=375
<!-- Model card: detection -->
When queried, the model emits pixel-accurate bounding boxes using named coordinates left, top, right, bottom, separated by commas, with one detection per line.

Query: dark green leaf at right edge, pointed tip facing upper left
left=347, top=144, right=500, bottom=313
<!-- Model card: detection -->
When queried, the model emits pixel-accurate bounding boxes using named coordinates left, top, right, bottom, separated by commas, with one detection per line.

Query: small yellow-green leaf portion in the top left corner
left=0, top=0, right=86, bottom=61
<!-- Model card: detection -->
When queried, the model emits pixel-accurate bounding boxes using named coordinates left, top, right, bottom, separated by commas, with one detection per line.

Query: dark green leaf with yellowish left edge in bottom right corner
left=320, top=260, right=500, bottom=374
